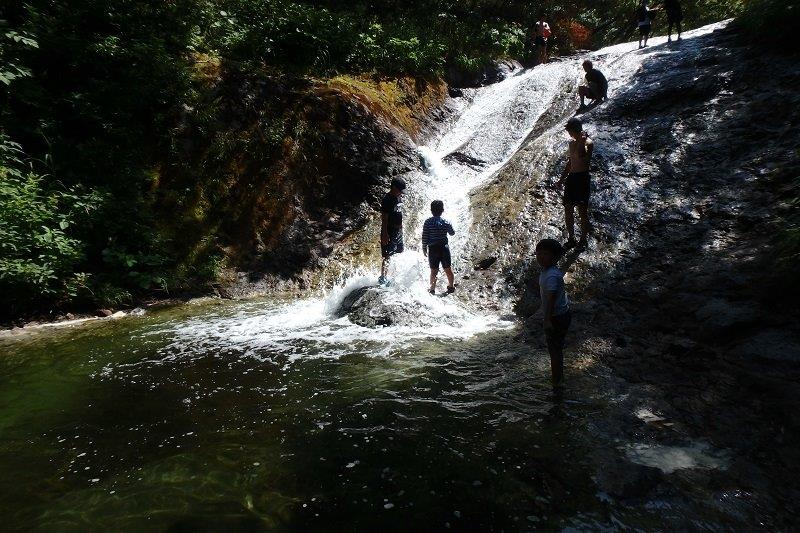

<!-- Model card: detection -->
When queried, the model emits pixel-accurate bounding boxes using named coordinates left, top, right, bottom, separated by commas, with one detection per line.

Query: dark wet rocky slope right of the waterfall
left=456, top=22, right=800, bottom=528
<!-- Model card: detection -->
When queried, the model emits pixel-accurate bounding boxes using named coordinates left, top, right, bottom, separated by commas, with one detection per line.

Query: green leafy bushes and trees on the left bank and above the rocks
left=0, top=0, right=768, bottom=316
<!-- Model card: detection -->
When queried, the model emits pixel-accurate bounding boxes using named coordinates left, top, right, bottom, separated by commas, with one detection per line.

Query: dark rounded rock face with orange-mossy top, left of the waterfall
left=163, top=65, right=449, bottom=295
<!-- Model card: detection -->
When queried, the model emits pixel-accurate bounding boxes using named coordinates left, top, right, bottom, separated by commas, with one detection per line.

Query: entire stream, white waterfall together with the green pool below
left=0, top=22, right=764, bottom=531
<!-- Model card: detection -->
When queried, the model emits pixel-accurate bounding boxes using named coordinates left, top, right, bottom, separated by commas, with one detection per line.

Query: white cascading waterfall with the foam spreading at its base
left=139, top=63, right=592, bottom=358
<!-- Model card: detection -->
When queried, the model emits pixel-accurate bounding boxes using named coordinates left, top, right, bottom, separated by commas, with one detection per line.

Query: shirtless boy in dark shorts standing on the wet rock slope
left=558, top=117, right=594, bottom=248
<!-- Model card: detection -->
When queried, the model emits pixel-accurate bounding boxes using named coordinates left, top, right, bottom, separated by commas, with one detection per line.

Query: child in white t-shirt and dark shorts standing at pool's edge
left=536, top=239, right=572, bottom=388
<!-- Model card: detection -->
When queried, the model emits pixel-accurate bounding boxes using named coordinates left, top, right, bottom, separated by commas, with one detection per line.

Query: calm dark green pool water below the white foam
left=0, top=302, right=764, bottom=531
